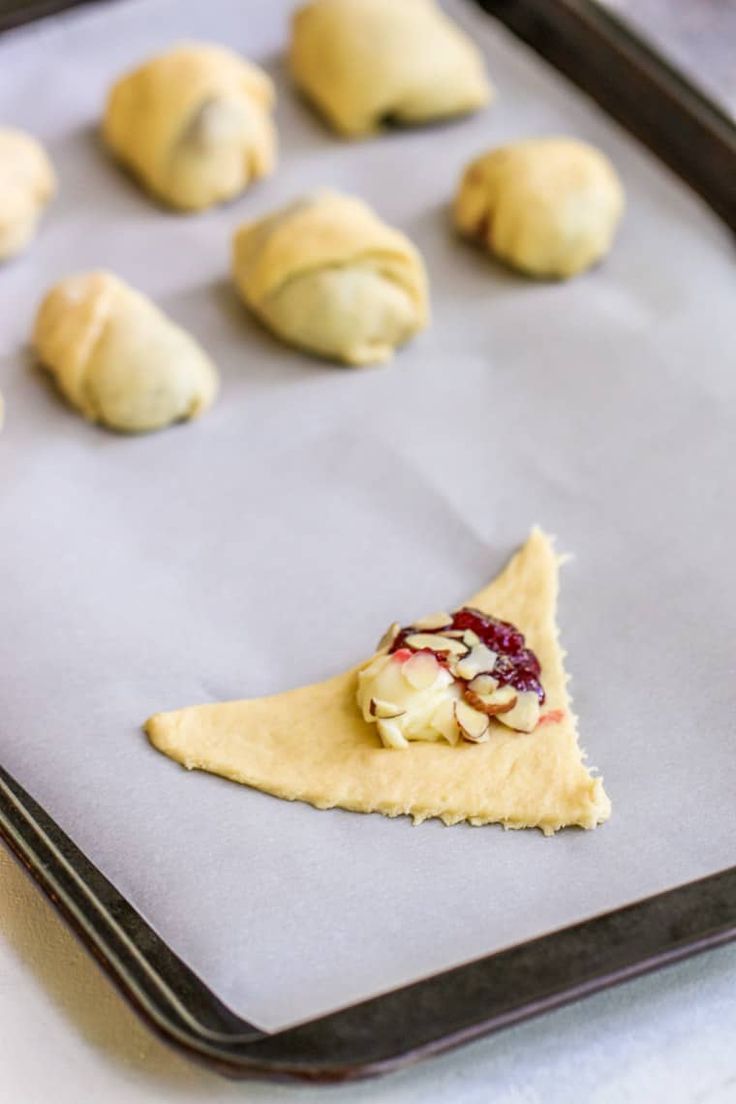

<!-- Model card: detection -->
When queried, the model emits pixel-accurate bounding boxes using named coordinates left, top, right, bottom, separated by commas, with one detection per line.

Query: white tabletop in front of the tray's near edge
left=0, top=849, right=736, bottom=1104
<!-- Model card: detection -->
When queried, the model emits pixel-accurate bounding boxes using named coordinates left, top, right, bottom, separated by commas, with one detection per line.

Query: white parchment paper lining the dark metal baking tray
left=0, top=0, right=736, bottom=1029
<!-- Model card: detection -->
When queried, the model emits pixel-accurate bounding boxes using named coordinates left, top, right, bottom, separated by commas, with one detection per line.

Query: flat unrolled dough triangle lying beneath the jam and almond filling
left=146, top=529, right=610, bottom=835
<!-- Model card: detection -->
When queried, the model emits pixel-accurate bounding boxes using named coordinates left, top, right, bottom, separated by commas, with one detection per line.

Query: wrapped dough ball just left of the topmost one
left=103, top=43, right=276, bottom=211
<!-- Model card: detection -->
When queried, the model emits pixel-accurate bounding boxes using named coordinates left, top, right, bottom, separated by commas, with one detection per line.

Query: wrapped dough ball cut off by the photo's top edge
left=290, top=0, right=492, bottom=135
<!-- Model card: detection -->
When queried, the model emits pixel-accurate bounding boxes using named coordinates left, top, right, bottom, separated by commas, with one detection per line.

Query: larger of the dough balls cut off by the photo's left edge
left=0, top=127, right=56, bottom=261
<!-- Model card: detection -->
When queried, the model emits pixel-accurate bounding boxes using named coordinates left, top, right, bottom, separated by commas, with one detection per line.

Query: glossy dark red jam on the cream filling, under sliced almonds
left=388, top=606, right=545, bottom=704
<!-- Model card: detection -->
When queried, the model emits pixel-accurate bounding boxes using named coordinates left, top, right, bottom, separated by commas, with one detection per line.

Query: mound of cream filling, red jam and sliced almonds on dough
left=358, top=606, right=544, bottom=749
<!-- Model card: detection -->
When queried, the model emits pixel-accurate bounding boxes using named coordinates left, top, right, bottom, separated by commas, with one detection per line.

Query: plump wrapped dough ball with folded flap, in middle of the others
left=233, top=190, right=428, bottom=364
